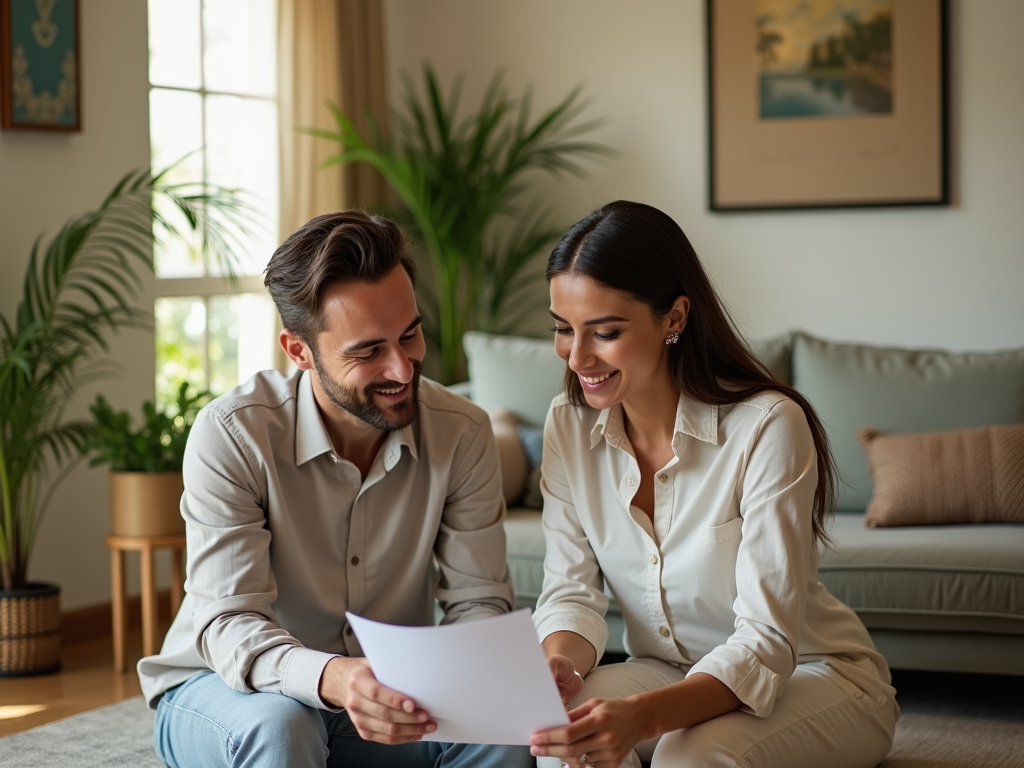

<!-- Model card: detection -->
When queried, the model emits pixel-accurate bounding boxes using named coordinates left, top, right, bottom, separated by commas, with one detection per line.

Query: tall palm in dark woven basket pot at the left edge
left=0, top=171, right=252, bottom=676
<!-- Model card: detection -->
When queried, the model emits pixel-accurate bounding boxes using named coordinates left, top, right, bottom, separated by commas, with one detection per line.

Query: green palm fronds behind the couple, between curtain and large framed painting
left=308, top=66, right=610, bottom=384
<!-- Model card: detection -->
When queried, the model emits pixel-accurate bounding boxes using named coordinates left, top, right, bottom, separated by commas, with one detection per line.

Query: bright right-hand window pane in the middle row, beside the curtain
left=206, top=96, right=279, bottom=274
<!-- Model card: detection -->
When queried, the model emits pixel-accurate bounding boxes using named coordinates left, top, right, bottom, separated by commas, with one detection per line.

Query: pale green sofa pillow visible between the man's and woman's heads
left=463, top=331, right=565, bottom=427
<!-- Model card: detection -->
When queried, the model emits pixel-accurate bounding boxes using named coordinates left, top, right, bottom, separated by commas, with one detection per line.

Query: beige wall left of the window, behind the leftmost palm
left=0, top=0, right=155, bottom=609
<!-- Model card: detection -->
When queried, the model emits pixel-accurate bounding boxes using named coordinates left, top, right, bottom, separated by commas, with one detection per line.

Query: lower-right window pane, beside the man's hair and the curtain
left=208, top=294, right=275, bottom=394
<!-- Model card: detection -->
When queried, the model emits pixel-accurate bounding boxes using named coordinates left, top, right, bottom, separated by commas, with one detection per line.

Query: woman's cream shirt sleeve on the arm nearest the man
left=534, top=414, right=608, bottom=658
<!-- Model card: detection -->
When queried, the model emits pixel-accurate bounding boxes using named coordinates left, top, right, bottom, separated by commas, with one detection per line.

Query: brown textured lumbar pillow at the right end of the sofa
left=857, top=424, right=1024, bottom=527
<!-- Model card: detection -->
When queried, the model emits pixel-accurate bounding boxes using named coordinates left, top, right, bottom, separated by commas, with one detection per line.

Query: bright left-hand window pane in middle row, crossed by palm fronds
left=150, top=88, right=204, bottom=278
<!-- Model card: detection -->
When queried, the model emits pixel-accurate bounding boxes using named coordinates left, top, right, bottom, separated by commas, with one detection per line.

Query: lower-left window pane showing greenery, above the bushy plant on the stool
left=154, top=296, right=206, bottom=406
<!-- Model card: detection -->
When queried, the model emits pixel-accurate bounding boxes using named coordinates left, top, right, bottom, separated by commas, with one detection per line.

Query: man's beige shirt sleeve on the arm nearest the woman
left=434, top=412, right=515, bottom=624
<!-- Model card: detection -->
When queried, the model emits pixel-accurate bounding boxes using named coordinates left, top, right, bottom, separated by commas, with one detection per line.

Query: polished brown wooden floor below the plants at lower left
left=0, top=626, right=157, bottom=736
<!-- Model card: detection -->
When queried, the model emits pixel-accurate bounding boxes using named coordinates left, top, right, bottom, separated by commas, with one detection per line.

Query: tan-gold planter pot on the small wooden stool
left=111, top=472, right=185, bottom=537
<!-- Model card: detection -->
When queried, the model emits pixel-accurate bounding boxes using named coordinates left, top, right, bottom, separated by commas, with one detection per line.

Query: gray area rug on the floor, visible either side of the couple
left=0, top=672, right=1024, bottom=768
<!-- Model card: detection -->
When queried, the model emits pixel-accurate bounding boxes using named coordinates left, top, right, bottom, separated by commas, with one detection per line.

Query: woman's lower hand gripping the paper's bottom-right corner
left=529, top=696, right=655, bottom=768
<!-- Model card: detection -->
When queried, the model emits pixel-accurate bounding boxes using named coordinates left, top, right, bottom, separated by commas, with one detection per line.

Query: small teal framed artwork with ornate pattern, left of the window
left=0, top=0, right=82, bottom=131
